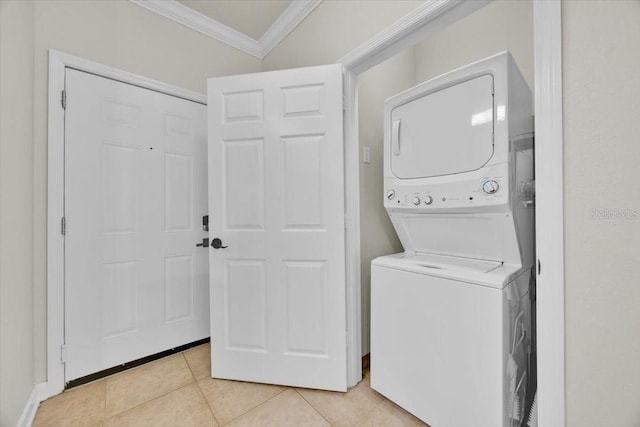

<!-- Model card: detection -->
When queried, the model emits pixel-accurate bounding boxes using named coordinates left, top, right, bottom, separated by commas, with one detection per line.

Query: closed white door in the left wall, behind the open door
left=65, top=69, right=209, bottom=381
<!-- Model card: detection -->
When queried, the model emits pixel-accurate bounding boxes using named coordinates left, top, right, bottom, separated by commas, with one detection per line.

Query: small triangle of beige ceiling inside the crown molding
left=178, top=0, right=291, bottom=40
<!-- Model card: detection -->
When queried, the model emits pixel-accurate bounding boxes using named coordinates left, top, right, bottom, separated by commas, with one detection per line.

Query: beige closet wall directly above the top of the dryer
left=415, top=0, right=533, bottom=93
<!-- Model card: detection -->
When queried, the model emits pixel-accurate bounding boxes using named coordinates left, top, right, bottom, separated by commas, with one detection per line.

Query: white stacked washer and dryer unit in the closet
left=371, top=52, right=535, bottom=427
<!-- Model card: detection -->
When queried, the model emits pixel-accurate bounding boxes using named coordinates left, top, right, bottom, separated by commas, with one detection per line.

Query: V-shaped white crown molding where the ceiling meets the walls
left=129, top=0, right=322, bottom=59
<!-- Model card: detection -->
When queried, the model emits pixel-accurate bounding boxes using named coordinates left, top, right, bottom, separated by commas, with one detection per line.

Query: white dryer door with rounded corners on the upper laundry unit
left=387, top=74, right=496, bottom=179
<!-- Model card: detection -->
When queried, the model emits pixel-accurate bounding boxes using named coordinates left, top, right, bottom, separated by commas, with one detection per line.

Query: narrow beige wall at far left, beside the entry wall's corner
left=0, top=1, right=34, bottom=426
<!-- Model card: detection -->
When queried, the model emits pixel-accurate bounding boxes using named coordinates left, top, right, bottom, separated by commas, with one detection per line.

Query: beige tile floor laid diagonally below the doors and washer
left=33, top=344, right=426, bottom=427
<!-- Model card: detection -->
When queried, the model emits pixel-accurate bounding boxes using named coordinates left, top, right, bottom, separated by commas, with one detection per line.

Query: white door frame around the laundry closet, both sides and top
left=337, top=0, right=565, bottom=427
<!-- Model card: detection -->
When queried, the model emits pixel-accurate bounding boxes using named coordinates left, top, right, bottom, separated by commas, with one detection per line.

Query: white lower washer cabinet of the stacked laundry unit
left=371, top=257, right=530, bottom=427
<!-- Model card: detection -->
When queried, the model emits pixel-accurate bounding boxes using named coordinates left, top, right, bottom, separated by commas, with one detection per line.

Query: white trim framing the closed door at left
left=45, top=49, right=207, bottom=400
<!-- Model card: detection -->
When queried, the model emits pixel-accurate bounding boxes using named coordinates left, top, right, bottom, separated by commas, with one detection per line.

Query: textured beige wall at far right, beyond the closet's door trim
left=562, top=0, right=640, bottom=427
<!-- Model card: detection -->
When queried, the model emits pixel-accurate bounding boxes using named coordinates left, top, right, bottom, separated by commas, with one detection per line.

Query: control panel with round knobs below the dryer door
left=384, top=176, right=509, bottom=209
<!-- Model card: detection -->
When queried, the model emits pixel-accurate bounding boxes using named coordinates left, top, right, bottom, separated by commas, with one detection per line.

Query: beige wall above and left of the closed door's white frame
left=30, top=0, right=262, bottom=382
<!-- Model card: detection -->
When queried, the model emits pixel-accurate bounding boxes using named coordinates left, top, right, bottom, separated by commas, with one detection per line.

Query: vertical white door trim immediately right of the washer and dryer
left=533, top=1, right=565, bottom=427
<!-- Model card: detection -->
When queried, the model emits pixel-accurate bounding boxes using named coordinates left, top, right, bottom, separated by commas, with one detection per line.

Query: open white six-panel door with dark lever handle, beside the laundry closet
left=208, top=65, right=347, bottom=391
